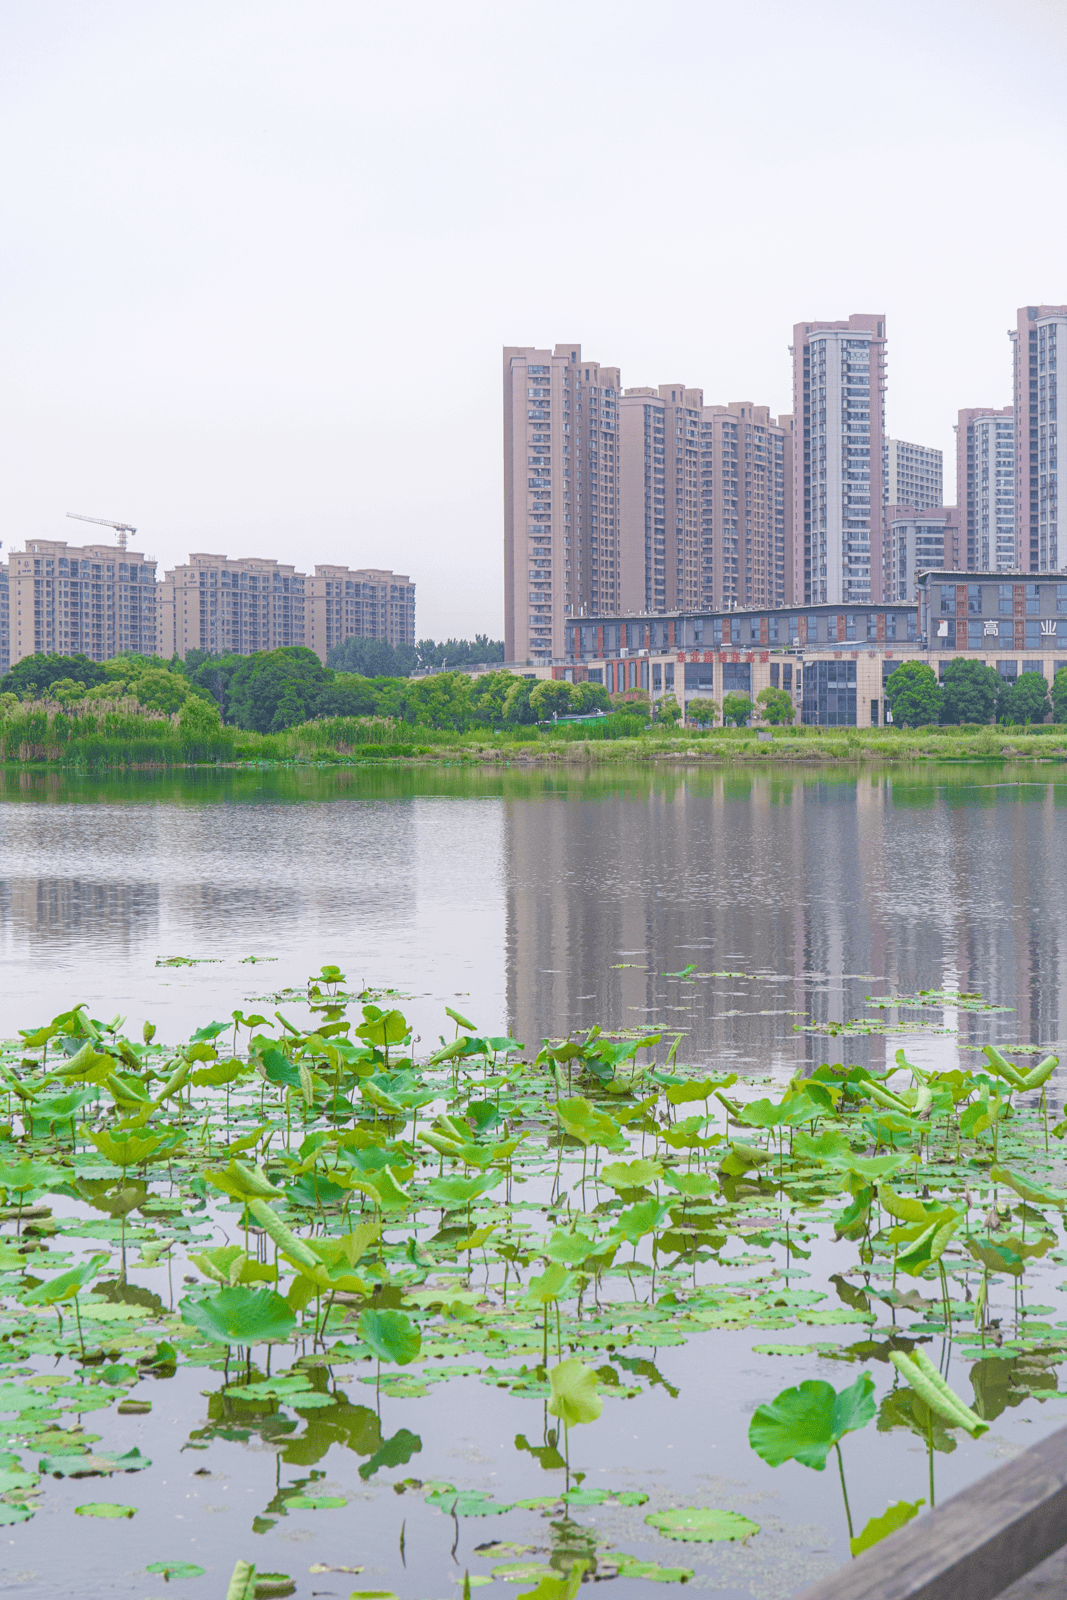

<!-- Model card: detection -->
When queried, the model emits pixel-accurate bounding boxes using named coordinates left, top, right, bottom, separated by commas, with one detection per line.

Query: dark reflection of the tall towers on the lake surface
left=506, top=770, right=1067, bottom=1070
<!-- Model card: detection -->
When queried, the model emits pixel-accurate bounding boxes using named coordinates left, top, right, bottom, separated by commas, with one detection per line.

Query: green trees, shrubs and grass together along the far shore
left=0, top=648, right=1067, bottom=771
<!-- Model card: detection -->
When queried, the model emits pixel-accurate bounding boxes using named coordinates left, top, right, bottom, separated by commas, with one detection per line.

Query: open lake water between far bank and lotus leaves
left=0, top=765, right=1067, bottom=1072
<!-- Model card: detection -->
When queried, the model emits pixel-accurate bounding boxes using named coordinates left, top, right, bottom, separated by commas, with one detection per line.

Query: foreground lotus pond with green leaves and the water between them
left=0, top=966, right=1067, bottom=1600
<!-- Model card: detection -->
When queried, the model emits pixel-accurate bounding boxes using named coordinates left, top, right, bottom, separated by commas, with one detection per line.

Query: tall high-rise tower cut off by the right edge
left=1008, top=306, right=1067, bottom=573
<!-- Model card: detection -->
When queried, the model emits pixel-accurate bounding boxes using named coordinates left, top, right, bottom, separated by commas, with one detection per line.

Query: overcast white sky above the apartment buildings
left=0, top=0, right=1067, bottom=637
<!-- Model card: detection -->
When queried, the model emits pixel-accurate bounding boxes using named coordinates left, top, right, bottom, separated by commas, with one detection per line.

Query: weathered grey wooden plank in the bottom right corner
left=798, top=1429, right=1067, bottom=1600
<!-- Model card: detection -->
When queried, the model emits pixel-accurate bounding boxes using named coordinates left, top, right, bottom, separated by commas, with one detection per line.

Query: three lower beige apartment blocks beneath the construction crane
left=0, top=539, right=414, bottom=675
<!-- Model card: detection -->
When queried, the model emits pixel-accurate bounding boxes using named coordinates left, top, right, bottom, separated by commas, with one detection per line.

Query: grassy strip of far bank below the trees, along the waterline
left=0, top=702, right=1067, bottom=771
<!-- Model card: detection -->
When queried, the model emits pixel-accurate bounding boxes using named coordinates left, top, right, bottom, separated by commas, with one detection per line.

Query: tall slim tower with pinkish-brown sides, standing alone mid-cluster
left=790, top=314, right=886, bottom=605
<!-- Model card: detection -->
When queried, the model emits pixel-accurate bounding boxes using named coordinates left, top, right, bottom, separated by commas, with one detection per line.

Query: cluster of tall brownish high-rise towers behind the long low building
left=504, top=306, right=1067, bottom=667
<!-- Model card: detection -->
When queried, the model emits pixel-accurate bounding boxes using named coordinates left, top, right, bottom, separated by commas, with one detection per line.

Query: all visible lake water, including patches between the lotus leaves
left=0, top=765, right=1067, bottom=1600
